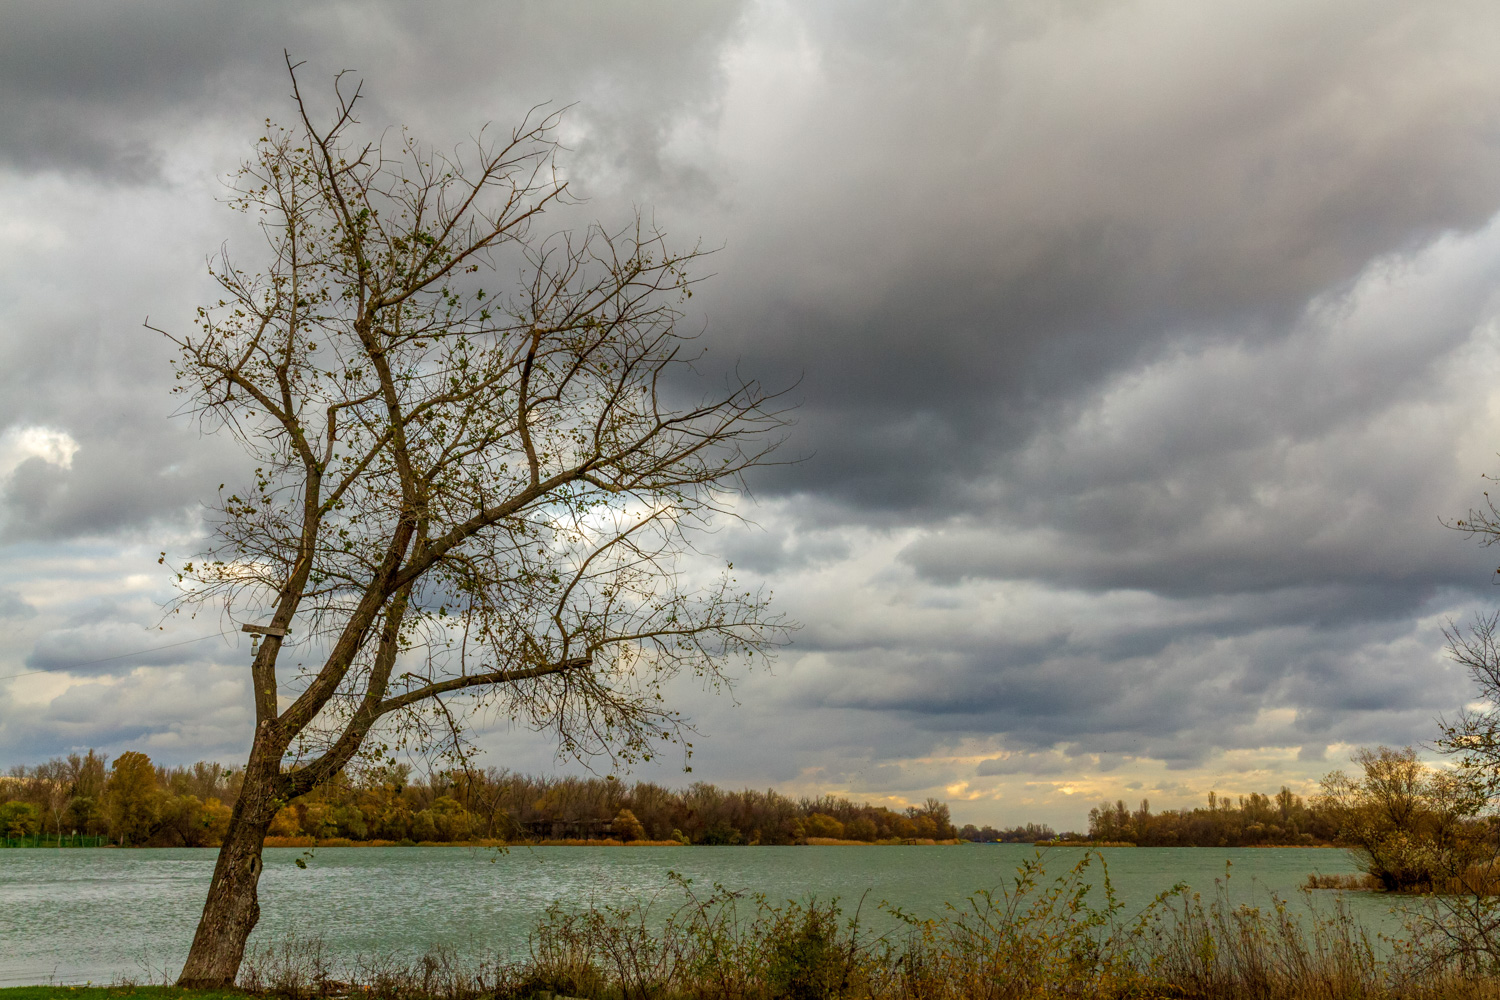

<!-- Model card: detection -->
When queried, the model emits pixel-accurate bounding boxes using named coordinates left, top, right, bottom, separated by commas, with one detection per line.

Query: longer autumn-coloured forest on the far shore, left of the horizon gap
left=0, top=751, right=960, bottom=847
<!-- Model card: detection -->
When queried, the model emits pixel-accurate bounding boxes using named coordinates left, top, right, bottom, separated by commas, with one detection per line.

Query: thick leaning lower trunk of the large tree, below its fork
left=177, top=747, right=281, bottom=990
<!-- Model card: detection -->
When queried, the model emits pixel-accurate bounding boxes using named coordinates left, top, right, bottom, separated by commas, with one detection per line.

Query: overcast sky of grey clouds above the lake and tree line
left=0, top=0, right=1500, bottom=826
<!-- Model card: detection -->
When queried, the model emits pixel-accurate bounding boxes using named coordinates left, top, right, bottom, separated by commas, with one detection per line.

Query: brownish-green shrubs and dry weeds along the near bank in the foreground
left=228, top=855, right=1500, bottom=1000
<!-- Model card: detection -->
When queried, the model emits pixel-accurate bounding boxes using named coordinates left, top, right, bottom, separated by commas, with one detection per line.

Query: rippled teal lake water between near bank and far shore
left=0, top=844, right=1392, bottom=985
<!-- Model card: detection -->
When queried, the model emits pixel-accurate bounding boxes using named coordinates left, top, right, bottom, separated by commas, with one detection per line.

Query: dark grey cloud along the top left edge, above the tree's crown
left=0, top=0, right=738, bottom=183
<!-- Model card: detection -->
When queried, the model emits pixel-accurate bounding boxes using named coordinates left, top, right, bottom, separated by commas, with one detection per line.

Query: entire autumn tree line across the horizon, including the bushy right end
left=0, top=748, right=1490, bottom=883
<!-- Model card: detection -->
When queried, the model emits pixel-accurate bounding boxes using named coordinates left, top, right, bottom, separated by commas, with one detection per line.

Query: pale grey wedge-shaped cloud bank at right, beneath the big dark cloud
left=906, top=228, right=1500, bottom=606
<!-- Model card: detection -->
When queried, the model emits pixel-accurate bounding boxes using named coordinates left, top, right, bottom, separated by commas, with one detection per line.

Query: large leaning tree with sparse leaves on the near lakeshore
left=164, top=60, right=791, bottom=987
